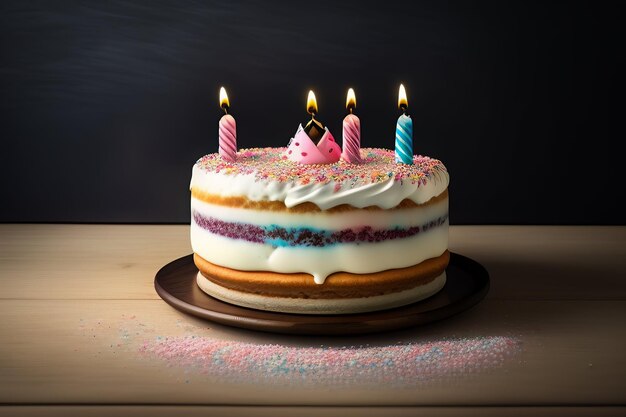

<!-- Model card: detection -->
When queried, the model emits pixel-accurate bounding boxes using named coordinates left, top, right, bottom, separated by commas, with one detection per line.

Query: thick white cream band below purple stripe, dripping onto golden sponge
left=191, top=216, right=448, bottom=284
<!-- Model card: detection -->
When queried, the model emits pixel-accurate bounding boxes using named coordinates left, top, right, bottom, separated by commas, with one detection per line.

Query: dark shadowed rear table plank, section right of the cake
left=450, top=226, right=626, bottom=300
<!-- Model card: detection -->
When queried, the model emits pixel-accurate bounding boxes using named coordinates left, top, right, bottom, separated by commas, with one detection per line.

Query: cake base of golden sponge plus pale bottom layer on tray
left=194, top=250, right=450, bottom=314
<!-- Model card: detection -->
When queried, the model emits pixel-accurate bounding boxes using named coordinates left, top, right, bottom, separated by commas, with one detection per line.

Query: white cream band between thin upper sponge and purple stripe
left=191, top=193, right=448, bottom=231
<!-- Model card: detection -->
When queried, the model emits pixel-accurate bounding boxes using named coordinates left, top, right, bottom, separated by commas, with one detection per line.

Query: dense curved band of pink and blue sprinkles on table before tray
left=140, top=335, right=519, bottom=386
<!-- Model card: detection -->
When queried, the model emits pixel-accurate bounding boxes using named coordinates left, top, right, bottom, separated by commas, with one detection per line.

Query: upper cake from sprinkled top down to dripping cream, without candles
left=191, top=148, right=449, bottom=284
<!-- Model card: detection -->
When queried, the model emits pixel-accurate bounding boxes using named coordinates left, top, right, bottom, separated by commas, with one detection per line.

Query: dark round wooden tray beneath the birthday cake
left=154, top=253, right=489, bottom=335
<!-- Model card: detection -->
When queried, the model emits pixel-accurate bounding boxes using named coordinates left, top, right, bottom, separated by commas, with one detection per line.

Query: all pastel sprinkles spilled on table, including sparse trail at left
left=80, top=315, right=523, bottom=389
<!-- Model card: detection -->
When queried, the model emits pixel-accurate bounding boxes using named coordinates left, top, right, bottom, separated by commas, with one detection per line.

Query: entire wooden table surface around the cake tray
left=0, top=224, right=626, bottom=416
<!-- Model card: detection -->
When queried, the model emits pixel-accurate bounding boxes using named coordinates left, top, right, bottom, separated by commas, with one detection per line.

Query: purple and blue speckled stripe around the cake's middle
left=192, top=211, right=448, bottom=247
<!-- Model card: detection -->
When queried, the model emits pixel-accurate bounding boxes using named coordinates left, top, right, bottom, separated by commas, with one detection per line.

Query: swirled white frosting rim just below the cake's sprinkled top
left=190, top=164, right=450, bottom=210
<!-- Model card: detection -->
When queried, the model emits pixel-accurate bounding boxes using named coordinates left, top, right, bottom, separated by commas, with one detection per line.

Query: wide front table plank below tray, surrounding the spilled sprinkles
left=0, top=299, right=626, bottom=406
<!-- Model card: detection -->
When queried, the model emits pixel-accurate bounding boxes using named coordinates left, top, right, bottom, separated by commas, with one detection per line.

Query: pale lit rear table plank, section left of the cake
left=0, top=225, right=191, bottom=300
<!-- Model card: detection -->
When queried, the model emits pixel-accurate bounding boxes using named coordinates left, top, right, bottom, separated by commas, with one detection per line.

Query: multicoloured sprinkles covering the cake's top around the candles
left=197, top=147, right=447, bottom=191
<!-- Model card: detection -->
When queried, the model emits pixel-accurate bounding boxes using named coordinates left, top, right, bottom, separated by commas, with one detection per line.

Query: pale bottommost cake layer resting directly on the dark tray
left=196, top=271, right=446, bottom=314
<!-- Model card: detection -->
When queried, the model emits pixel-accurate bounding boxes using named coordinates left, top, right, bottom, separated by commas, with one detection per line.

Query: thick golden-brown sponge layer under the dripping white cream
left=194, top=251, right=450, bottom=299
